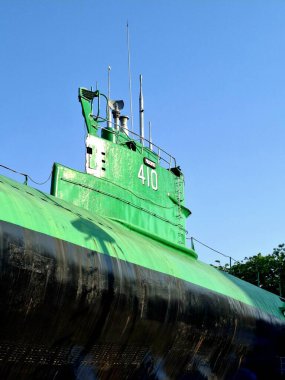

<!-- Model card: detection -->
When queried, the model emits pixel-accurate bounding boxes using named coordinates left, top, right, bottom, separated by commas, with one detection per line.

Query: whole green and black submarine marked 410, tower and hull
left=0, top=81, right=285, bottom=380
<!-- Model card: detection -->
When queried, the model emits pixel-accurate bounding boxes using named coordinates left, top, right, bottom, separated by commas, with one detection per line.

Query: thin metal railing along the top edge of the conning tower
left=96, top=117, right=176, bottom=169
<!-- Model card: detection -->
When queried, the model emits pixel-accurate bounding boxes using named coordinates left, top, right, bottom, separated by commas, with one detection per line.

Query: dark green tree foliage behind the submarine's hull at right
left=215, top=244, right=285, bottom=297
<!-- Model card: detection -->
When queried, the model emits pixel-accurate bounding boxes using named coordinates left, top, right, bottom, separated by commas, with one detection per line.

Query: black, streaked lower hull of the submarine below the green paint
left=0, top=222, right=285, bottom=380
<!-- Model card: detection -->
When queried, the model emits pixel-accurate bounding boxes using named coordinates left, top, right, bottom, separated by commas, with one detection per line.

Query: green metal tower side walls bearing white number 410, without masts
left=52, top=135, right=190, bottom=246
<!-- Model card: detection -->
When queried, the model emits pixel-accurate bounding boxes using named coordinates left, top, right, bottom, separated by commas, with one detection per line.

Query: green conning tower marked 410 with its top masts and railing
left=51, top=88, right=192, bottom=252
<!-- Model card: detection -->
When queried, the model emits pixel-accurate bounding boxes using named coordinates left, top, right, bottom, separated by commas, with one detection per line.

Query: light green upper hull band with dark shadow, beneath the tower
left=0, top=176, right=284, bottom=319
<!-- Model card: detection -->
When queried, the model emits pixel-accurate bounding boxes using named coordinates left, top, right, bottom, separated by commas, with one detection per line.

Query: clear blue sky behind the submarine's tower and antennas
left=0, top=0, right=285, bottom=263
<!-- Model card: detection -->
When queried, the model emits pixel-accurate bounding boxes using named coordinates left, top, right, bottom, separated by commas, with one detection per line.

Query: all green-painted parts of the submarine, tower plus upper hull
left=0, top=85, right=284, bottom=319
